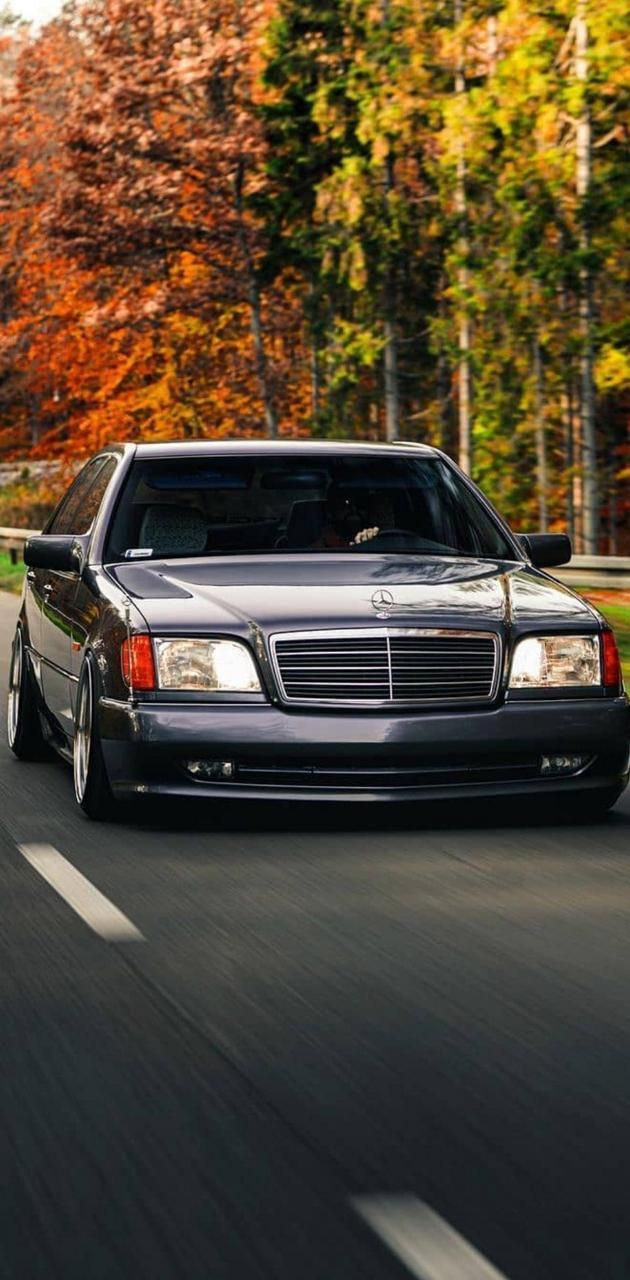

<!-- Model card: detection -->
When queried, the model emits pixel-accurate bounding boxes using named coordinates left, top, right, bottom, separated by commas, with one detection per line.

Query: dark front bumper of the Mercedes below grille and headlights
left=99, top=698, right=630, bottom=801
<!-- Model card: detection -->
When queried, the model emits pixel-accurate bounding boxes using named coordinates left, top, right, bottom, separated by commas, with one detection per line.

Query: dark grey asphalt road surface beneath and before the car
left=0, top=596, right=630, bottom=1280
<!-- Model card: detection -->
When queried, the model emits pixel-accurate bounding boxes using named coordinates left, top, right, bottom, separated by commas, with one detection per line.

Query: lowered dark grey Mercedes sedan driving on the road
left=8, top=440, right=630, bottom=819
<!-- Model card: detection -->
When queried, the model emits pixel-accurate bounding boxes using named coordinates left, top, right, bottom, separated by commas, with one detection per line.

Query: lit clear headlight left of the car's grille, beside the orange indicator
left=155, top=640, right=260, bottom=694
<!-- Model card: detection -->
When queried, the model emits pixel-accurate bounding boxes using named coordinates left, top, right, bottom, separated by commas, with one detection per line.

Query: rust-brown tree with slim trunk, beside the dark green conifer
left=56, top=0, right=289, bottom=436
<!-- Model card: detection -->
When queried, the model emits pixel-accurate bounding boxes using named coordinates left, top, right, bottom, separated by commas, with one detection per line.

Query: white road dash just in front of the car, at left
left=18, top=845, right=145, bottom=942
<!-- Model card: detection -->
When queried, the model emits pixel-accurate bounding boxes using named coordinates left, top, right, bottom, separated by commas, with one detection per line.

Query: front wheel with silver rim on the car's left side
left=73, top=655, right=117, bottom=822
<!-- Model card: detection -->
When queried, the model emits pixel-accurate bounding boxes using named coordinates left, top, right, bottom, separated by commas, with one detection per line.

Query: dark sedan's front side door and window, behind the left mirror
left=39, top=456, right=117, bottom=737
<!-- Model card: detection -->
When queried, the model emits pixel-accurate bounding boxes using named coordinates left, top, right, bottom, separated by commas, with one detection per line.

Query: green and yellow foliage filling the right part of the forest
left=265, top=0, right=630, bottom=535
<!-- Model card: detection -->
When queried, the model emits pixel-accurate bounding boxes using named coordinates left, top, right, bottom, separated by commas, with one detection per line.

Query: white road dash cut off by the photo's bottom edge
left=351, top=1194, right=506, bottom=1280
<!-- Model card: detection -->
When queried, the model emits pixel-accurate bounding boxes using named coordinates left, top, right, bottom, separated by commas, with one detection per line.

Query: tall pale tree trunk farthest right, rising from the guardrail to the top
left=575, top=0, right=599, bottom=556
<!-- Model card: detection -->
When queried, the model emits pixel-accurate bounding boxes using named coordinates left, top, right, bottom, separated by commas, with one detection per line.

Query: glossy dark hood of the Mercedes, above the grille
left=114, top=553, right=597, bottom=635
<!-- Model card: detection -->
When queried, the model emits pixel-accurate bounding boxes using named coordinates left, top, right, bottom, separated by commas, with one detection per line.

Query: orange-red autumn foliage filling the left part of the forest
left=0, top=0, right=305, bottom=454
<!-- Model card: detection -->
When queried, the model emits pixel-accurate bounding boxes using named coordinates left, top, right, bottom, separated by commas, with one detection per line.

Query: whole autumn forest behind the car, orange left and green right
left=0, top=0, right=630, bottom=554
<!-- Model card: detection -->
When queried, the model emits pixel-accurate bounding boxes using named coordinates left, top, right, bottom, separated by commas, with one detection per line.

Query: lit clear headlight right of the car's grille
left=510, top=636, right=602, bottom=689
